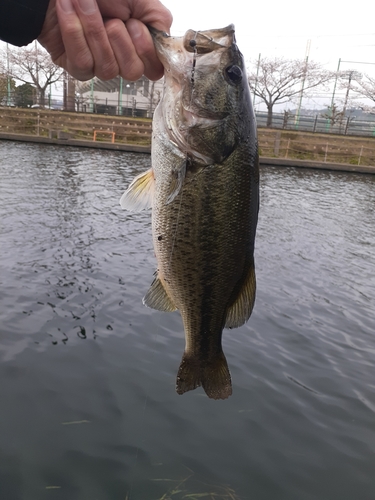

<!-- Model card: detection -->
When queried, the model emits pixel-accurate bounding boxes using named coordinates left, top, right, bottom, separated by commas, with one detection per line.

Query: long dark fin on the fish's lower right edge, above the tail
left=225, top=259, right=256, bottom=328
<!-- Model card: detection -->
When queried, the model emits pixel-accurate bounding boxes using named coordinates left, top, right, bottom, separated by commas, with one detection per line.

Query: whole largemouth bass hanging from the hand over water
left=120, top=25, right=259, bottom=399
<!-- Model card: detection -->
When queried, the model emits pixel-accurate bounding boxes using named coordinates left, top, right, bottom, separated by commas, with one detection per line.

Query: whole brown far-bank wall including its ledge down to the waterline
left=0, top=108, right=375, bottom=173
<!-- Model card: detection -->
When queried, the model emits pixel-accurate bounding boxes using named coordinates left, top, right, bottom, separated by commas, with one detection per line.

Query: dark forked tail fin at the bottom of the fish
left=176, top=352, right=232, bottom=399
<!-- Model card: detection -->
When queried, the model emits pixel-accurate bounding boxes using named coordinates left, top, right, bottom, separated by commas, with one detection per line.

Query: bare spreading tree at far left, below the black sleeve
left=4, top=43, right=64, bottom=106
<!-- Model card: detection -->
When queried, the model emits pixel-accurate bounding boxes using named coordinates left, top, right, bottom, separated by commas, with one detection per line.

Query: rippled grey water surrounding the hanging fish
left=0, top=142, right=375, bottom=500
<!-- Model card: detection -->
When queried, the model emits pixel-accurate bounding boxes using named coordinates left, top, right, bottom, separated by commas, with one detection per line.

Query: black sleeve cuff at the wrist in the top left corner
left=0, top=0, right=49, bottom=46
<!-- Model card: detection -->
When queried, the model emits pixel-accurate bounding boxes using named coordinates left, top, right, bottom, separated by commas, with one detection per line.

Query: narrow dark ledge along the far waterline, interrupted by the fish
left=0, top=132, right=375, bottom=174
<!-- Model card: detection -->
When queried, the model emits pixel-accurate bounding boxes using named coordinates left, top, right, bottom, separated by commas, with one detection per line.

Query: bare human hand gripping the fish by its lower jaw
left=38, top=0, right=172, bottom=80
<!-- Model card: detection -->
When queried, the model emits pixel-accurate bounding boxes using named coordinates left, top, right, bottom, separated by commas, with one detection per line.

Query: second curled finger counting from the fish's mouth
left=105, top=19, right=144, bottom=81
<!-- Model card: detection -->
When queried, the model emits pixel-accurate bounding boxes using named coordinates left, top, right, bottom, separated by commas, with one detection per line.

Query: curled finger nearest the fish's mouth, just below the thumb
left=126, top=19, right=164, bottom=80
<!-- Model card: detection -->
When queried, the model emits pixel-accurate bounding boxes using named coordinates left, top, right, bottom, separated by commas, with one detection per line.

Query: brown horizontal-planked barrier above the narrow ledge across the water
left=0, top=107, right=375, bottom=166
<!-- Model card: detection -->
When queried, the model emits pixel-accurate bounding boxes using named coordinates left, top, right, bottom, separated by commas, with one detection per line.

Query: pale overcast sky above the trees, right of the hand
left=162, top=0, right=375, bottom=75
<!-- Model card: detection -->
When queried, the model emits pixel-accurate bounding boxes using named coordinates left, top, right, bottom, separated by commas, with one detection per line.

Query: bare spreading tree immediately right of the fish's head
left=248, top=58, right=333, bottom=127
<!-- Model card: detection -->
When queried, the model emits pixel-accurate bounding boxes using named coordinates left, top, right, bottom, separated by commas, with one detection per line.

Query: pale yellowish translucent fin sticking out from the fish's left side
left=120, top=168, right=155, bottom=212
